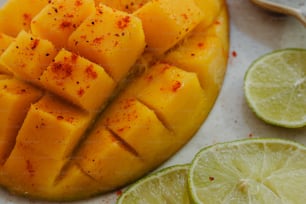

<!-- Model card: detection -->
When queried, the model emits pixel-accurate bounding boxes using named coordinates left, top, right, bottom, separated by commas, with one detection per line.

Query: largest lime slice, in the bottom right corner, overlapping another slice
left=188, top=139, right=306, bottom=204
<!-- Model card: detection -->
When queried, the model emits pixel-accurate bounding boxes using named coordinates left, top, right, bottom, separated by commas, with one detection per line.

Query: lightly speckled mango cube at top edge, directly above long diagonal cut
left=135, top=0, right=204, bottom=54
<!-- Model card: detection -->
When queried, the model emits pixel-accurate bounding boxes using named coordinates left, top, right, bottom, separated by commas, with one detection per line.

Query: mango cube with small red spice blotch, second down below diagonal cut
left=129, top=64, right=210, bottom=137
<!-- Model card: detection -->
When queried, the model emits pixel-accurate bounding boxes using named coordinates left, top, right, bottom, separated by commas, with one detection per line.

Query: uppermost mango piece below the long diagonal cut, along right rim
left=164, top=6, right=229, bottom=102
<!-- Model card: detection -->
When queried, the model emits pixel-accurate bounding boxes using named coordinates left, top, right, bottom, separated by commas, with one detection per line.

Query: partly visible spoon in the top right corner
left=251, top=0, right=306, bottom=27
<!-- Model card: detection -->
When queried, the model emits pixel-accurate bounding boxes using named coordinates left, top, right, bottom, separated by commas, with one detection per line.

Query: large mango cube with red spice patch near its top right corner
left=68, top=4, right=145, bottom=81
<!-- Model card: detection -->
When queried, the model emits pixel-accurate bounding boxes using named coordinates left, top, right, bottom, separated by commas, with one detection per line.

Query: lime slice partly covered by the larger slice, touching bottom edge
left=117, top=165, right=190, bottom=204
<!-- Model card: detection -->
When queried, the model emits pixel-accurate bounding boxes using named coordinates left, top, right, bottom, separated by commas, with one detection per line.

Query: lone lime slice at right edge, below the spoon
left=244, top=49, right=306, bottom=128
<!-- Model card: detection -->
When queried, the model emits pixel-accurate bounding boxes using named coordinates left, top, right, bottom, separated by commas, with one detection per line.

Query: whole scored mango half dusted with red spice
left=0, top=0, right=228, bottom=200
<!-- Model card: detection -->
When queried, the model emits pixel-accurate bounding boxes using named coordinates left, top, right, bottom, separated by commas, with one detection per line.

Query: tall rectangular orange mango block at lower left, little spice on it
left=0, top=95, right=92, bottom=196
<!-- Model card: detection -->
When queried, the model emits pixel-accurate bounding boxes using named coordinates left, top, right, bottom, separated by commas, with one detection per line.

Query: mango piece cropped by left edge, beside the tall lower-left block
left=0, top=79, right=42, bottom=164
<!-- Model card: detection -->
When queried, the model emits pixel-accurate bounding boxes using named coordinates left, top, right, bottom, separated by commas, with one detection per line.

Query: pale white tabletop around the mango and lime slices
left=0, top=0, right=306, bottom=204
